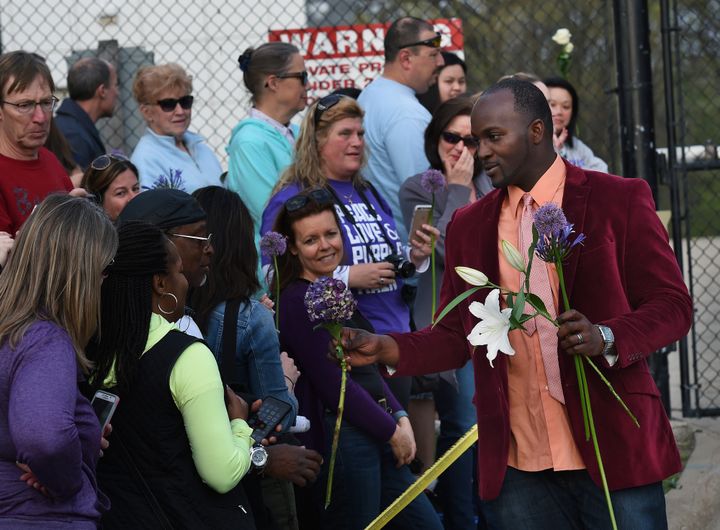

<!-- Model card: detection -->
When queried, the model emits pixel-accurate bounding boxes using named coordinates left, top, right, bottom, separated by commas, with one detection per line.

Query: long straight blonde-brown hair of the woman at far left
left=0, top=195, right=118, bottom=372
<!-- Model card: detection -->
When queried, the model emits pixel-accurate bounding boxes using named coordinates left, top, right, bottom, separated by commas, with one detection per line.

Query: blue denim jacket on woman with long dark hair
left=205, top=300, right=298, bottom=431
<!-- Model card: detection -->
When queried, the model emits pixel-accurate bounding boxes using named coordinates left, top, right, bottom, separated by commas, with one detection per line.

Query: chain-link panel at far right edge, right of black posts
left=667, top=0, right=720, bottom=415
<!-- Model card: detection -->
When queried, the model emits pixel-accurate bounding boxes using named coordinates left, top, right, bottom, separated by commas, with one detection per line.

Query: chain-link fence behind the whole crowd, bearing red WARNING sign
left=0, top=0, right=720, bottom=410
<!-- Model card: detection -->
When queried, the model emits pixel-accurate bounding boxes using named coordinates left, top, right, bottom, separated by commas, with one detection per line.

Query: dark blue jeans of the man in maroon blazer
left=482, top=467, right=667, bottom=530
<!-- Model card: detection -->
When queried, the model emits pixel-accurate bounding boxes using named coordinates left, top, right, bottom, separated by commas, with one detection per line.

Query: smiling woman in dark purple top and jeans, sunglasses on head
left=275, top=189, right=442, bottom=529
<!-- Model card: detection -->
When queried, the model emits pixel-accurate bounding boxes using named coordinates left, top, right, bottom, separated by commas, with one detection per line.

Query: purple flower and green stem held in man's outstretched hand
left=305, top=277, right=357, bottom=508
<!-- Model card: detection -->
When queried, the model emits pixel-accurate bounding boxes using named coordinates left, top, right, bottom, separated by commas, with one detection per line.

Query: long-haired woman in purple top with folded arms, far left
left=0, top=195, right=117, bottom=529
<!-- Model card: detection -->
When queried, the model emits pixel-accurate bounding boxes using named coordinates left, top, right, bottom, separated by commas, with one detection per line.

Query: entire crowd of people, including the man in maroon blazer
left=0, top=11, right=691, bottom=530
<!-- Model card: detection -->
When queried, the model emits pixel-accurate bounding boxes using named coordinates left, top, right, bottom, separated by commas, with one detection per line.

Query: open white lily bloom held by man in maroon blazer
left=467, top=289, right=515, bottom=368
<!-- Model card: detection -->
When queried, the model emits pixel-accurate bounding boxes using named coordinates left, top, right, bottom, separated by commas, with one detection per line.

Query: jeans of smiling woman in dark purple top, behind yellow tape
left=321, top=414, right=442, bottom=530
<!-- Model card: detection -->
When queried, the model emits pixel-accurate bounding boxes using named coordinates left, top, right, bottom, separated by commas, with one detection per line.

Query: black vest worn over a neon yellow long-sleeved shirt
left=97, top=331, right=255, bottom=530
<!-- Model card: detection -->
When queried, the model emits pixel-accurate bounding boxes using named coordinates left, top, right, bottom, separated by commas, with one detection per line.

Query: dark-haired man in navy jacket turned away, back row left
left=55, top=57, right=118, bottom=170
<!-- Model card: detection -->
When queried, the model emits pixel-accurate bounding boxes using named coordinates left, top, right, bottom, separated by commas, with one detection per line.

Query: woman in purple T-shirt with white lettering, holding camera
left=260, top=94, right=440, bottom=403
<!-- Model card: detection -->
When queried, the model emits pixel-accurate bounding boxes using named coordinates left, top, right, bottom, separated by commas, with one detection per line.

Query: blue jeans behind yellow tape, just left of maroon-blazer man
left=434, top=361, right=483, bottom=530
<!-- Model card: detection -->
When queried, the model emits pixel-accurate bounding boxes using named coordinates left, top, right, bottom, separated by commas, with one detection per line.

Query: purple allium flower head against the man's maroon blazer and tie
left=534, top=202, right=585, bottom=263
